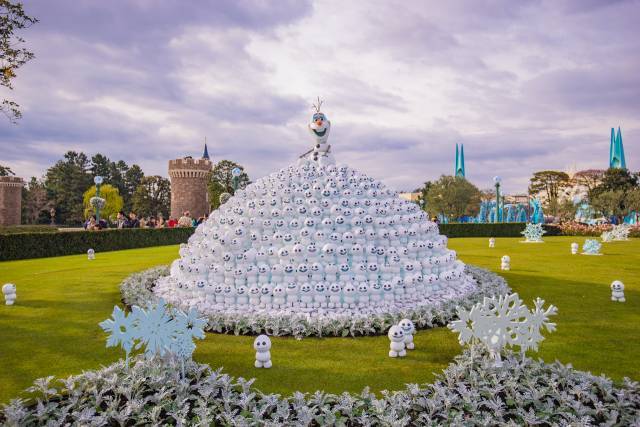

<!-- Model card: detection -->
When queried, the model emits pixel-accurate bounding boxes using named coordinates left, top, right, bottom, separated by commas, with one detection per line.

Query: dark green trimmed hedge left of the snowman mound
left=0, top=228, right=194, bottom=261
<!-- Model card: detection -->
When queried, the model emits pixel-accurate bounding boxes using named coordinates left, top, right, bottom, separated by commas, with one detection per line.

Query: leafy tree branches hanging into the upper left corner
left=0, top=0, right=38, bottom=123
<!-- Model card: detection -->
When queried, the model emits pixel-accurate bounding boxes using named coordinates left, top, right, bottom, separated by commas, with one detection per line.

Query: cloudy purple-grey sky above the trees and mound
left=0, top=0, right=640, bottom=192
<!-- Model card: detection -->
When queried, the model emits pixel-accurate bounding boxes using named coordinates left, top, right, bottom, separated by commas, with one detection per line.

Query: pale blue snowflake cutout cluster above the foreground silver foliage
left=100, top=299, right=207, bottom=371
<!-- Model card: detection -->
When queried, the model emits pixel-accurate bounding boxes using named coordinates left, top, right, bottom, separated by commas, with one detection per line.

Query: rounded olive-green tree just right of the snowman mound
left=427, top=175, right=481, bottom=220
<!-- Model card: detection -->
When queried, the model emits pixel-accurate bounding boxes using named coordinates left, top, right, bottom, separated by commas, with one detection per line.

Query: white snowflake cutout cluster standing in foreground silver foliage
left=447, top=293, right=558, bottom=367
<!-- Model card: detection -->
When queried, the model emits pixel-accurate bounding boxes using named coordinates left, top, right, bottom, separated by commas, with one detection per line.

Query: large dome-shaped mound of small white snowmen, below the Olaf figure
left=154, top=160, right=475, bottom=315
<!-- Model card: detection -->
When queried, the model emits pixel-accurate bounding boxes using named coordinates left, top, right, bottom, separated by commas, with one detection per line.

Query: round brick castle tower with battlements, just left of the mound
left=169, top=144, right=212, bottom=219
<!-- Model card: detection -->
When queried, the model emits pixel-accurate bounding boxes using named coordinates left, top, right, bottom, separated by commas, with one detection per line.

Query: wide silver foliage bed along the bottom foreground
left=0, top=348, right=640, bottom=426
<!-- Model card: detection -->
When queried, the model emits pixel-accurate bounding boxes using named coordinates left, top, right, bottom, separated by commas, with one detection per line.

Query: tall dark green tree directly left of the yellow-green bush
left=45, top=151, right=93, bottom=224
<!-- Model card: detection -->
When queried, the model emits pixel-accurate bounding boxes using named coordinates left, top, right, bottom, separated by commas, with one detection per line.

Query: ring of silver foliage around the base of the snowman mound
left=120, top=265, right=509, bottom=339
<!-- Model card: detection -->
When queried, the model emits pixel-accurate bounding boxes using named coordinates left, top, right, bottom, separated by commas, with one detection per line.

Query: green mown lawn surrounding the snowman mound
left=0, top=237, right=640, bottom=402
